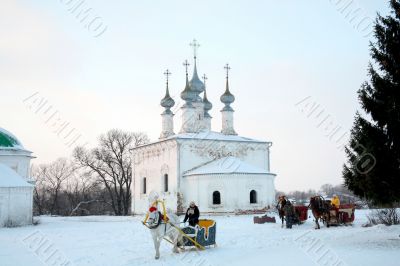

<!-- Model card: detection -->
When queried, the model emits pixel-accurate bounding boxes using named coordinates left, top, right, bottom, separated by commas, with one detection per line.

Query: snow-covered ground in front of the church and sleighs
left=0, top=210, right=400, bottom=266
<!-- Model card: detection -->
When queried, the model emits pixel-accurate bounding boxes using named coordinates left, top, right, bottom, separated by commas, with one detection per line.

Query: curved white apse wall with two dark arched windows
left=183, top=174, right=275, bottom=212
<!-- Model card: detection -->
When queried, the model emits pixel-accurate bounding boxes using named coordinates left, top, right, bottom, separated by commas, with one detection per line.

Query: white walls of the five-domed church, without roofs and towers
left=132, top=135, right=275, bottom=214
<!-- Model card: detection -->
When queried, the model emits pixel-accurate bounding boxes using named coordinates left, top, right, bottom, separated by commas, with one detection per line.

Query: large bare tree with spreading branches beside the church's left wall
left=73, top=129, right=149, bottom=215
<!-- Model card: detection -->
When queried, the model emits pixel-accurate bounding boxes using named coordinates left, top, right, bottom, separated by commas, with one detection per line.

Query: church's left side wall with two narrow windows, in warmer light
left=132, top=140, right=178, bottom=213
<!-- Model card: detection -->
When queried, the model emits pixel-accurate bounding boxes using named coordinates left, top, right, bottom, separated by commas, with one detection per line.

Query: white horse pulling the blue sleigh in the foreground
left=148, top=193, right=182, bottom=260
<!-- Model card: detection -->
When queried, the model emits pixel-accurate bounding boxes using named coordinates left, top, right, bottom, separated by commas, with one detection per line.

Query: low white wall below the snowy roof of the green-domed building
left=0, top=187, right=33, bottom=227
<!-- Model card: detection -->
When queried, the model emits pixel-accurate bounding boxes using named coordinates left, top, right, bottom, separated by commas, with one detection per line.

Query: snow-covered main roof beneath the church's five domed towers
left=168, top=131, right=267, bottom=143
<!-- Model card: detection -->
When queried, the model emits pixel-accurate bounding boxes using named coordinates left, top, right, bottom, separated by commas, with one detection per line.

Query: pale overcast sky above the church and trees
left=0, top=0, right=388, bottom=191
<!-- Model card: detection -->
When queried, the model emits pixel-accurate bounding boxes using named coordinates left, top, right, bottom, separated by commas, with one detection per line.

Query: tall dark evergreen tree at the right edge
left=343, top=0, right=400, bottom=206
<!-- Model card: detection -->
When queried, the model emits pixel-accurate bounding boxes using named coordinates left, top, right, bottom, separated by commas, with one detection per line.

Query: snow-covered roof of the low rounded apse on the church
left=184, top=156, right=271, bottom=176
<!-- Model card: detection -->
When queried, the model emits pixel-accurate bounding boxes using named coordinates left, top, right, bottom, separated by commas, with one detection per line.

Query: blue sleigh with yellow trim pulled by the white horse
left=182, top=220, right=217, bottom=247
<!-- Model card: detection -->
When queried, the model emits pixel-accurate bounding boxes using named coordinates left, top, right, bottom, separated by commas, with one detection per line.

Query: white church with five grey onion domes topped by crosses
left=132, top=40, right=276, bottom=214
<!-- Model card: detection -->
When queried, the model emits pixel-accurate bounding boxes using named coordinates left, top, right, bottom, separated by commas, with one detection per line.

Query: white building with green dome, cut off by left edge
left=0, top=128, right=34, bottom=227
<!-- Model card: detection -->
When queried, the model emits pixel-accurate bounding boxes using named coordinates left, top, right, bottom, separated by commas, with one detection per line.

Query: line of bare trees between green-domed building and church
left=32, top=129, right=149, bottom=216
